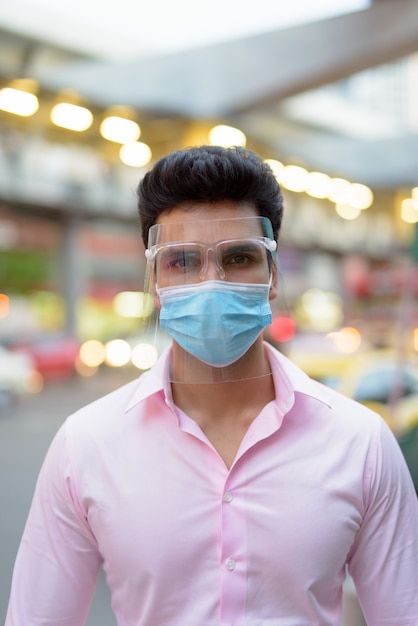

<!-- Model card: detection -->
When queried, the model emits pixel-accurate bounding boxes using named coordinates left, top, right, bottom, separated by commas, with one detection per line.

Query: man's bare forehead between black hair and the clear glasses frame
left=154, top=200, right=263, bottom=243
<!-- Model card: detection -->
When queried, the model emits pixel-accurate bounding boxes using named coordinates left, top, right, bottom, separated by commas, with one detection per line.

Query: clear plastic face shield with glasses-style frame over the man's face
left=145, top=214, right=277, bottom=383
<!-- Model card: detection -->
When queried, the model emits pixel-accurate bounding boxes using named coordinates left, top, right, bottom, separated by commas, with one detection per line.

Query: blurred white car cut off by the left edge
left=0, top=346, right=43, bottom=412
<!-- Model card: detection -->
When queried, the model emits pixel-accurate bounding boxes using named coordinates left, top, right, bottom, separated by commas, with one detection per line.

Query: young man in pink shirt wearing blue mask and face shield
left=6, top=147, right=418, bottom=626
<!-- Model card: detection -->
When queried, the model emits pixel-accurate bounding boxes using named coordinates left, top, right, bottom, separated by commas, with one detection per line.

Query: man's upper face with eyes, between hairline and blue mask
left=149, top=200, right=277, bottom=299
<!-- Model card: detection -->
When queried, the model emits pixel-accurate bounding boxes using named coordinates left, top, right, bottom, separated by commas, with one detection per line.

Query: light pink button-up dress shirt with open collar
left=6, top=345, right=418, bottom=626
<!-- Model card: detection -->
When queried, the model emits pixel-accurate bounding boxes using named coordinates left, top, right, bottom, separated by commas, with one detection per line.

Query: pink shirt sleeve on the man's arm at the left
left=5, top=424, right=101, bottom=626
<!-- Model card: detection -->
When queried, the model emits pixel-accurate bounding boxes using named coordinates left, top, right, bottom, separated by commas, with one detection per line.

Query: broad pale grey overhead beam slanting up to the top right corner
left=31, top=0, right=418, bottom=116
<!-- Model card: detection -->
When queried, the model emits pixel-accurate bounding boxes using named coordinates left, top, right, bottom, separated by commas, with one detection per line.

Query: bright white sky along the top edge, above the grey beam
left=0, top=0, right=371, bottom=60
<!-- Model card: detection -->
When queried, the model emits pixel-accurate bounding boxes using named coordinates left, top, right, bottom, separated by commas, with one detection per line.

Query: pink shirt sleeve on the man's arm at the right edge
left=349, top=420, right=418, bottom=626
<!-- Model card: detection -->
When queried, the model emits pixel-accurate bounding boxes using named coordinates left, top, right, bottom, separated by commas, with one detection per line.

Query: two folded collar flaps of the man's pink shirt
left=126, top=343, right=330, bottom=411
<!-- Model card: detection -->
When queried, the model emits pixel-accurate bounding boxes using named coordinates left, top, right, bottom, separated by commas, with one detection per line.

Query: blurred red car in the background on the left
left=9, top=335, right=81, bottom=380
